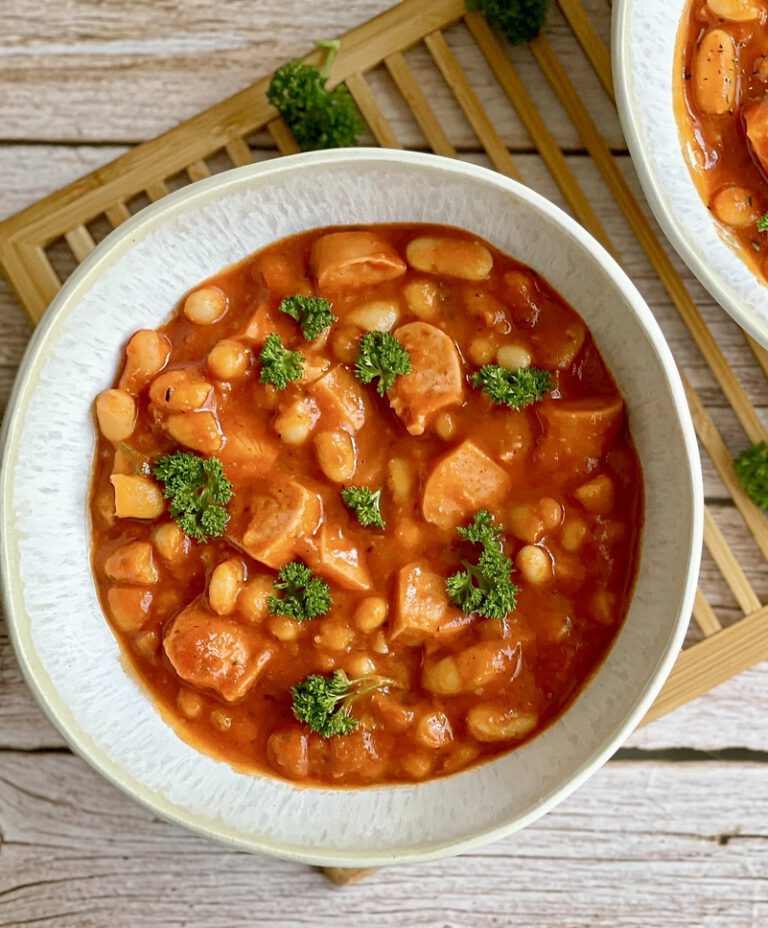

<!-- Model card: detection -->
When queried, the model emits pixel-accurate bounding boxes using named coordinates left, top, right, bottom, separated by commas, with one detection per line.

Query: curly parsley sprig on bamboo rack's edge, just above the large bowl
left=267, top=41, right=365, bottom=151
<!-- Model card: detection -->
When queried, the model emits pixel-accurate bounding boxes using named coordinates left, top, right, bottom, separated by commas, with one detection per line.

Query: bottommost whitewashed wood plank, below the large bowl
left=0, top=753, right=768, bottom=928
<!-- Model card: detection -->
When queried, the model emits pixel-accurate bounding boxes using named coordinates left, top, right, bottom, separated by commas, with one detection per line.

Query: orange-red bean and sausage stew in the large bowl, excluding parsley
left=91, top=225, right=643, bottom=786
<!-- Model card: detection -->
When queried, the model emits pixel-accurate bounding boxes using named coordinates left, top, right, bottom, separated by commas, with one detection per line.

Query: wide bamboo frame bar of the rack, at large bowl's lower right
left=640, top=606, right=768, bottom=725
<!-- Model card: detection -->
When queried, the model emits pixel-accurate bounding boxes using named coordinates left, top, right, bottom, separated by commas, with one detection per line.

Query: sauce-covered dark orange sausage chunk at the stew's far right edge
left=534, top=396, right=624, bottom=473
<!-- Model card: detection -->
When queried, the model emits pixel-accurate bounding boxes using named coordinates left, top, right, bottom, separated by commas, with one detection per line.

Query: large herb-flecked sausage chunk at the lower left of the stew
left=163, top=603, right=272, bottom=702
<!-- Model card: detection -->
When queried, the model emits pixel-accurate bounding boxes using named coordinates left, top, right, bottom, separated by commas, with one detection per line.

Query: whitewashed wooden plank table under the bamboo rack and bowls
left=0, top=0, right=768, bottom=928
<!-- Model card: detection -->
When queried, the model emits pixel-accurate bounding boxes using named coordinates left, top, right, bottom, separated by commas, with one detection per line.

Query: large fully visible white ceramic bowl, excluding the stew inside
left=2, top=149, right=702, bottom=866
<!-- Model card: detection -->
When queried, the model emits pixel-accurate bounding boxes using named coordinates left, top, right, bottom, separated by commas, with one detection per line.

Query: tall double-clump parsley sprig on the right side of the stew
left=445, top=509, right=519, bottom=619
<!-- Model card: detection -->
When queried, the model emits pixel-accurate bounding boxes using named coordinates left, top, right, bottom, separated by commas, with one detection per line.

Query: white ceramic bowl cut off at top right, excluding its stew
left=612, top=0, right=768, bottom=348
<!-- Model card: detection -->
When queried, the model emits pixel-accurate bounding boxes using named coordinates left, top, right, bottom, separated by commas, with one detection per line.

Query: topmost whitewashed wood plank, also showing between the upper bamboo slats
left=0, top=0, right=623, bottom=148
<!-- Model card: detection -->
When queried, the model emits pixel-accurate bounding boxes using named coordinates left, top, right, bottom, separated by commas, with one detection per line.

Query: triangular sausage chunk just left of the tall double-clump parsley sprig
left=392, top=561, right=463, bottom=645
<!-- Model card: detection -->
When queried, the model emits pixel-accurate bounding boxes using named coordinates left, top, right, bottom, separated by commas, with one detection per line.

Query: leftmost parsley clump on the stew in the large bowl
left=152, top=451, right=235, bottom=541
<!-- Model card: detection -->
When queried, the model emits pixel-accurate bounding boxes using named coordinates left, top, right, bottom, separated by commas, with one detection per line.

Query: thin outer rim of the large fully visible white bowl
left=0, top=148, right=703, bottom=867
